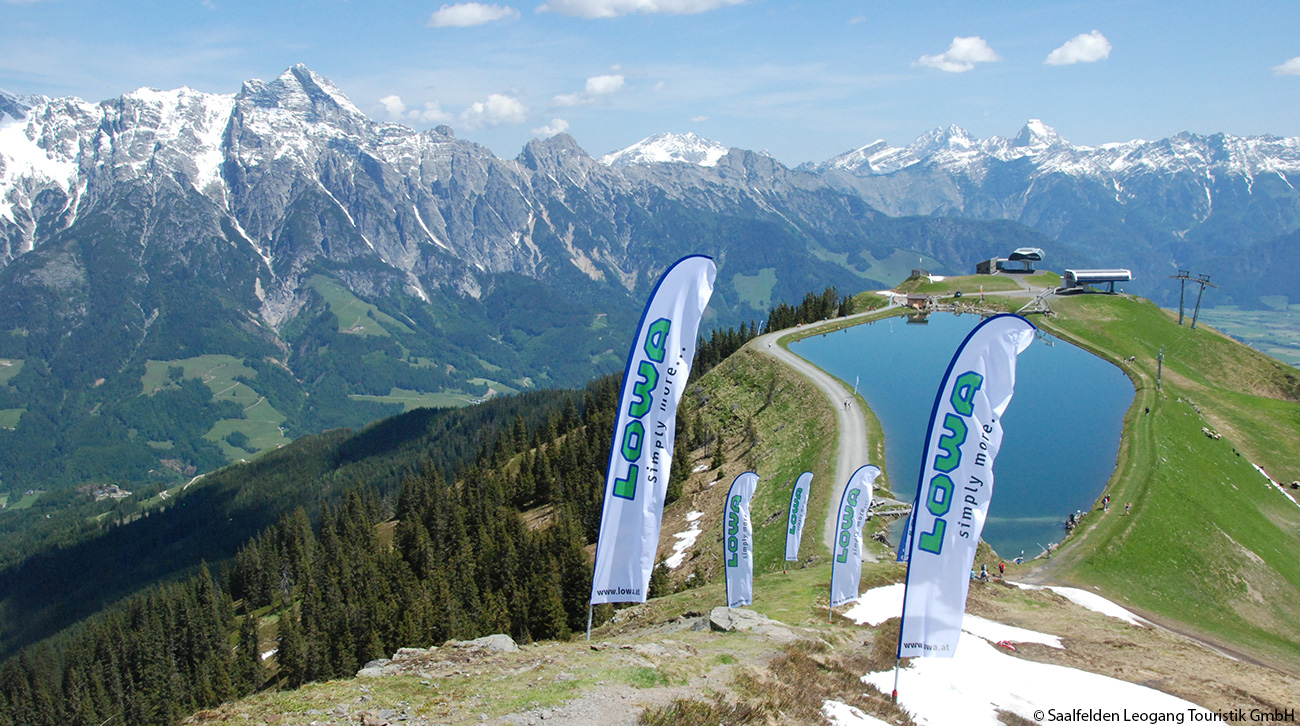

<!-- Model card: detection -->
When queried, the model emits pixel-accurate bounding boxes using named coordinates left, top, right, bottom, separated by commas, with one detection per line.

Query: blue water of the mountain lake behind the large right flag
left=790, top=314, right=1134, bottom=558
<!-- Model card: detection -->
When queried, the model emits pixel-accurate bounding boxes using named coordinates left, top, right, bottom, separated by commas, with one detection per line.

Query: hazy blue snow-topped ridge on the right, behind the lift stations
left=801, top=120, right=1300, bottom=306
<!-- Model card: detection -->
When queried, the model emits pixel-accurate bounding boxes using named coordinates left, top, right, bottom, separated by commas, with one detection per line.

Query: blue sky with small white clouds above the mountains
left=0, top=0, right=1300, bottom=165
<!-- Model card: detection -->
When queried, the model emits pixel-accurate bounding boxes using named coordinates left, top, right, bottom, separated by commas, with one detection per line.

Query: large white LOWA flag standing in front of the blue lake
left=898, top=315, right=1034, bottom=658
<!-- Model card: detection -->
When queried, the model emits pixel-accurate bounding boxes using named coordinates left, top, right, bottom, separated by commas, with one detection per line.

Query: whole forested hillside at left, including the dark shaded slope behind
left=0, top=289, right=850, bottom=726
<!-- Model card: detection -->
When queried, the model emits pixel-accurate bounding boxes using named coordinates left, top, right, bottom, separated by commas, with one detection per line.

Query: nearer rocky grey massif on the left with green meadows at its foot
left=0, top=65, right=1044, bottom=489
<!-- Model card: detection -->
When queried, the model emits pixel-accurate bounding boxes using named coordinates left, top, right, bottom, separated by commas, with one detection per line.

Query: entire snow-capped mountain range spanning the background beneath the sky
left=0, top=65, right=1300, bottom=494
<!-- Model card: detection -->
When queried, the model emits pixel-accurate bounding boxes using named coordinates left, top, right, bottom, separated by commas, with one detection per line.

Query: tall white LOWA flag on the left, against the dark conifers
left=592, top=255, right=718, bottom=605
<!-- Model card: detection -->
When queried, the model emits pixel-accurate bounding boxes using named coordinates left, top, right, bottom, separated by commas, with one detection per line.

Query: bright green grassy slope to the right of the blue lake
left=1019, top=295, right=1300, bottom=673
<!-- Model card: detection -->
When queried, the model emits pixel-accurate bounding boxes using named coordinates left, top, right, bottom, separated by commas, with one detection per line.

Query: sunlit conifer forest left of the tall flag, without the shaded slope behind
left=0, top=290, right=848, bottom=726
